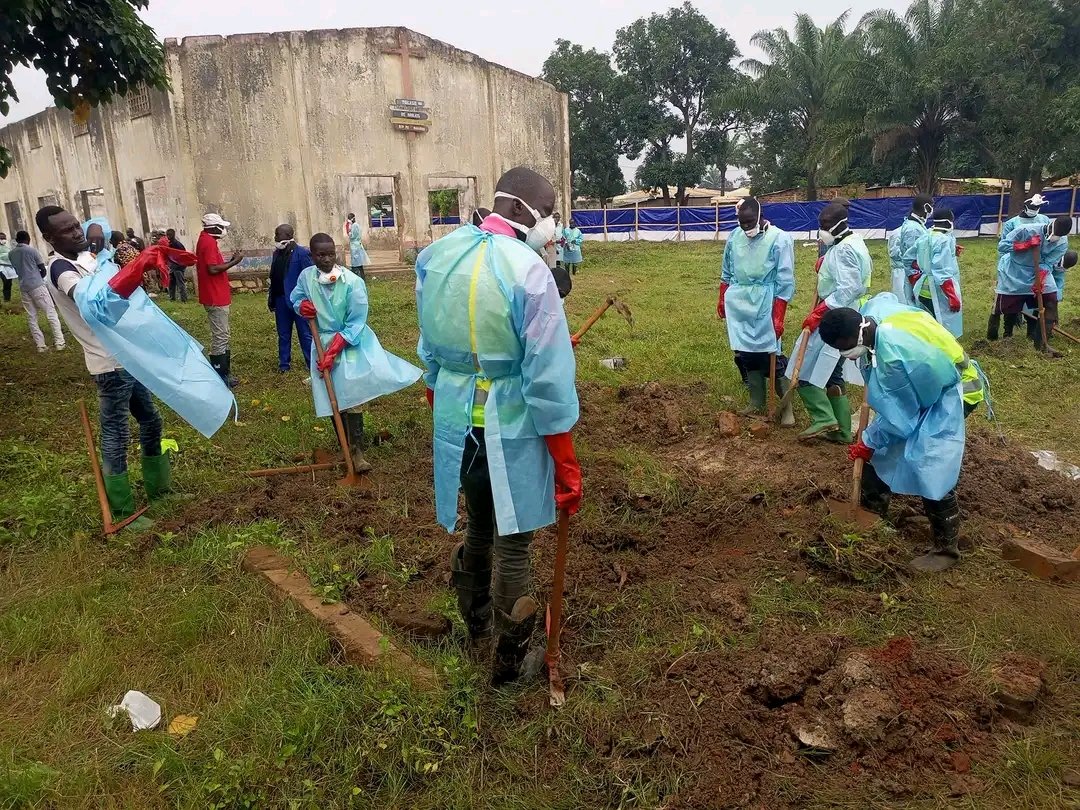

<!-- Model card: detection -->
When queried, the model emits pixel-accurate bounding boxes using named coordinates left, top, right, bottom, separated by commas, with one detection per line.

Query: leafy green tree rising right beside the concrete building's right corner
left=541, top=39, right=640, bottom=205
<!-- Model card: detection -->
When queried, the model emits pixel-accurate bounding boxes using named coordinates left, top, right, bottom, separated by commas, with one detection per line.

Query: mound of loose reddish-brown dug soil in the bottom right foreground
left=635, top=629, right=994, bottom=808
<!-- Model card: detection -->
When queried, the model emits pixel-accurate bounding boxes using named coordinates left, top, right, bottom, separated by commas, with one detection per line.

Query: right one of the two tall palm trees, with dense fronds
left=841, top=0, right=967, bottom=194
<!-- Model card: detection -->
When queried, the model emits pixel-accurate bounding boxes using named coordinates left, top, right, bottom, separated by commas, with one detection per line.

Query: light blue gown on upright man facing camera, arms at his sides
left=720, top=225, right=795, bottom=352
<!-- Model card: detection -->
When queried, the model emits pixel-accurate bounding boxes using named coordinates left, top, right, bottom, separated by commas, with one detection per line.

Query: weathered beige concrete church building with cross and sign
left=0, top=28, right=570, bottom=270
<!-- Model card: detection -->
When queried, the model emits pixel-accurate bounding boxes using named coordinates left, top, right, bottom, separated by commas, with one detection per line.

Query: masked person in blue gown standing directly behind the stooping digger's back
left=897, top=208, right=963, bottom=338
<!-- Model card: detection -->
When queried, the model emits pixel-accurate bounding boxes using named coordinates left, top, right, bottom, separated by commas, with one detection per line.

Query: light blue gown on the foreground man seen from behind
left=416, top=225, right=578, bottom=535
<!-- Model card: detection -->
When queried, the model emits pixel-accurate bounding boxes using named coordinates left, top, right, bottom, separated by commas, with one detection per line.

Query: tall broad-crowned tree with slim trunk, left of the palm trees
left=613, top=2, right=739, bottom=202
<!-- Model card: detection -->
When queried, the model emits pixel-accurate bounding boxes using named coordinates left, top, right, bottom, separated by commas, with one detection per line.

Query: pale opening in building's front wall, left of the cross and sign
left=334, top=174, right=402, bottom=267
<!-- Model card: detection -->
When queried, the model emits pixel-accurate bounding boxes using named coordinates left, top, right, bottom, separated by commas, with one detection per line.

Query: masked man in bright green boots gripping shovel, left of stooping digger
left=787, top=202, right=874, bottom=443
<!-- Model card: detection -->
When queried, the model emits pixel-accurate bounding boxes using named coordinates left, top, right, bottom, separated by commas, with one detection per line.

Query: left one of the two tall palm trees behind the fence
left=742, top=12, right=852, bottom=200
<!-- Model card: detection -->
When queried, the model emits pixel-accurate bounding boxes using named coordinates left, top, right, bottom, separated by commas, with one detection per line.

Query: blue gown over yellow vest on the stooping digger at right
left=860, top=295, right=966, bottom=500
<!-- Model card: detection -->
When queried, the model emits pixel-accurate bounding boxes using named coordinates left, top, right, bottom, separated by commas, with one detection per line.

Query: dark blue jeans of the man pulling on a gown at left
left=94, top=368, right=161, bottom=475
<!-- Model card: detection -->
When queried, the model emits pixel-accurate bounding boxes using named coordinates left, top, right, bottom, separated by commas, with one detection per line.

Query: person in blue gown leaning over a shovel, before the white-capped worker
left=995, top=216, right=1072, bottom=354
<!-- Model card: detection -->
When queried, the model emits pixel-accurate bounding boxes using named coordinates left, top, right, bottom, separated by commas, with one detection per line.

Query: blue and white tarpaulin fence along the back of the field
left=573, top=188, right=1078, bottom=241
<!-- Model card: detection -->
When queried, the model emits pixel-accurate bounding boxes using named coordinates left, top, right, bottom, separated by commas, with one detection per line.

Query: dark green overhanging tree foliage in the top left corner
left=0, top=0, right=168, bottom=177
